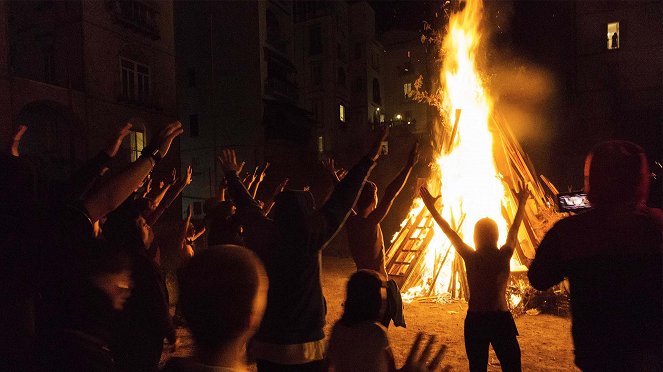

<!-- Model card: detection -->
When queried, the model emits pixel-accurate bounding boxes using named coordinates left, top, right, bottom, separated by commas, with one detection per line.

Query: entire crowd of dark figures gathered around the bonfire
left=0, top=122, right=663, bottom=372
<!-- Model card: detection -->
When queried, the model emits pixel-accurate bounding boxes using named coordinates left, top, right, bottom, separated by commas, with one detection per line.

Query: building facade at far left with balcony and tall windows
left=0, top=0, right=179, bottom=206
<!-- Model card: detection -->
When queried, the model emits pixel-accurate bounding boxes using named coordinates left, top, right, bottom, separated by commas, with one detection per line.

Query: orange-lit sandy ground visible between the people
left=164, top=257, right=578, bottom=371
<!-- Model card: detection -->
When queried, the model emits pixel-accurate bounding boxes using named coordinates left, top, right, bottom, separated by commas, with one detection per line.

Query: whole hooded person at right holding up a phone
left=529, top=141, right=663, bottom=371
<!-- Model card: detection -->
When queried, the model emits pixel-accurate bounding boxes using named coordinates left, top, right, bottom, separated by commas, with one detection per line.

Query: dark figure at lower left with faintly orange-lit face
left=35, top=239, right=132, bottom=372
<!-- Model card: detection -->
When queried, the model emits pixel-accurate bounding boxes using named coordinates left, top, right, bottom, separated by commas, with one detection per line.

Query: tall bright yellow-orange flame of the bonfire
left=403, top=0, right=519, bottom=301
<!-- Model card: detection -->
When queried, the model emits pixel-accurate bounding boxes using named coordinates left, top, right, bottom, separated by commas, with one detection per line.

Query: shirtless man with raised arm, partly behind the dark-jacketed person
left=346, top=142, right=419, bottom=327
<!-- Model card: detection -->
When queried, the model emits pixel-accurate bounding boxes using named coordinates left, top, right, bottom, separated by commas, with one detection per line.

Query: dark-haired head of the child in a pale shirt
left=341, top=270, right=386, bottom=325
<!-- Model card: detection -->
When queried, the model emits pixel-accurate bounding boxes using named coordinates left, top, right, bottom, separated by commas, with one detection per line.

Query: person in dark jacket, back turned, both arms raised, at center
left=227, top=158, right=375, bottom=344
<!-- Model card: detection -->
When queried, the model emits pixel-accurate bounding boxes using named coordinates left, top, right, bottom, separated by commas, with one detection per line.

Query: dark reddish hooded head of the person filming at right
left=584, top=141, right=649, bottom=206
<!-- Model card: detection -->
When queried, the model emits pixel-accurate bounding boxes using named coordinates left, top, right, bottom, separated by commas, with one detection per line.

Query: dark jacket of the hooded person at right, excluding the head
left=529, top=209, right=663, bottom=370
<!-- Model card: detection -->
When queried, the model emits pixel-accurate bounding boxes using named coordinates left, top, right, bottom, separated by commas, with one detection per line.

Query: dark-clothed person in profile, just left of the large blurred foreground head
left=104, top=201, right=176, bottom=371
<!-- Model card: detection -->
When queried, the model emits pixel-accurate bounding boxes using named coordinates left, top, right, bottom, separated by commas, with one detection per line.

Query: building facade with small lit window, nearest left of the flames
left=294, top=1, right=383, bottom=165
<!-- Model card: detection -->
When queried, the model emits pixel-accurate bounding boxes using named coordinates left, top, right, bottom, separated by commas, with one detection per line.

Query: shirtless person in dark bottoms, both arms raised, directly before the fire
left=421, top=187, right=529, bottom=372
